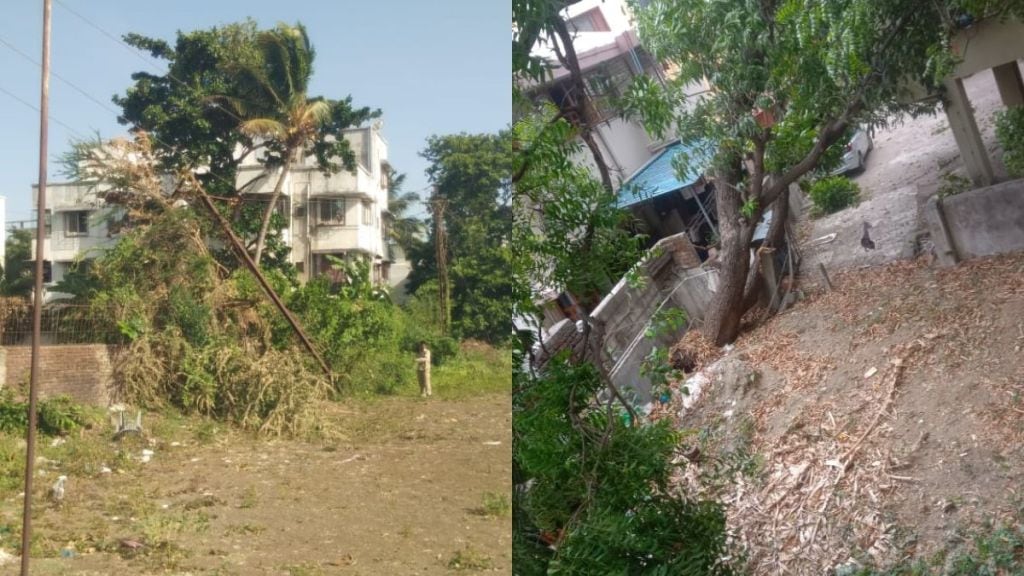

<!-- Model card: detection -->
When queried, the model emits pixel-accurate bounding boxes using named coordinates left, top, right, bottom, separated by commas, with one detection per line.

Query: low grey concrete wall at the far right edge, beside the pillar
left=925, top=179, right=1024, bottom=265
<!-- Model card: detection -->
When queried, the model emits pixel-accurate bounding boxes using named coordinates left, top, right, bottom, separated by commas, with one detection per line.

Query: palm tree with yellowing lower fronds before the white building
left=222, top=24, right=331, bottom=264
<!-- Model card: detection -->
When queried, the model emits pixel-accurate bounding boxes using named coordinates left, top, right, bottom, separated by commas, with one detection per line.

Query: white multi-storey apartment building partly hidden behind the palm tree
left=33, top=123, right=404, bottom=297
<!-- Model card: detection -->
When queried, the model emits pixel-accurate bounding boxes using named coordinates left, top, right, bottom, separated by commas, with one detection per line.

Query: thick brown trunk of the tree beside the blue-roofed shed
left=703, top=168, right=762, bottom=346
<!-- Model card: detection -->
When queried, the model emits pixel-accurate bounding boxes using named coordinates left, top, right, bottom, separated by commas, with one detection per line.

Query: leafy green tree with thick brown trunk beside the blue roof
left=626, top=0, right=1020, bottom=344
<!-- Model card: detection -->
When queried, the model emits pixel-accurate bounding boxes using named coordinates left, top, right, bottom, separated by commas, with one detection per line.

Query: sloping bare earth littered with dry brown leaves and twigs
left=667, top=254, right=1024, bottom=574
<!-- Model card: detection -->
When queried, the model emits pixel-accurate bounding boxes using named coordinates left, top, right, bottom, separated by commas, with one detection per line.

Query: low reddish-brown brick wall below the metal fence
left=0, top=344, right=117, bottom=406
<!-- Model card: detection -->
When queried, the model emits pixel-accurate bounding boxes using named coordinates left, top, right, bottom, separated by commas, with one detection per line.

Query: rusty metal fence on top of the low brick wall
left=0, top=299, right=125, bottom=346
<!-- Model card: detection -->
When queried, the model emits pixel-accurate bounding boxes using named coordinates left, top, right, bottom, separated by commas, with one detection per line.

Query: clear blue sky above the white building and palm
left=0, top=0, right=512, bottom=220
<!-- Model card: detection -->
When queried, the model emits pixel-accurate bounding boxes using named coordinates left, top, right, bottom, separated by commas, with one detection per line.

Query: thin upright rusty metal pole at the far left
left=22, top=0, right=50, bottom=565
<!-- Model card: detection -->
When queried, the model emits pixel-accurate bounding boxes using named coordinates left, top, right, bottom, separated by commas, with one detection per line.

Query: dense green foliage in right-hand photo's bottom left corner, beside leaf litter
left=513, top=360, right=731, bottom=575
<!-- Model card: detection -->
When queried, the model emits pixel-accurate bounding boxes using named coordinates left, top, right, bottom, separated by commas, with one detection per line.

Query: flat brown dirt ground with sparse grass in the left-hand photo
left=0, top=394, right=511, bottom=576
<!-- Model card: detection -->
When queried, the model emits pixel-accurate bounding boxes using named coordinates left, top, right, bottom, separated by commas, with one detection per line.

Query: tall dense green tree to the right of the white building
left=409, top=132, right=512, bottom=342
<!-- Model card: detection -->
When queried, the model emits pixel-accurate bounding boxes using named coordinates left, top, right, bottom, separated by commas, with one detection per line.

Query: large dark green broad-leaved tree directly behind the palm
left=114, top=20, right=380, bottom=263
